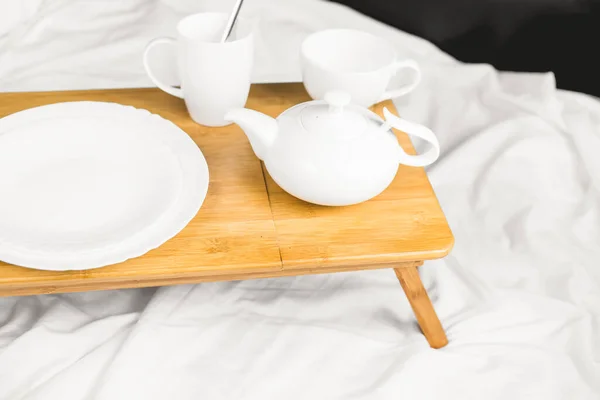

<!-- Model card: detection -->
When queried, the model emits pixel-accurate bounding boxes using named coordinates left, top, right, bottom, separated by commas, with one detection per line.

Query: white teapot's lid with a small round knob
left=300, top=91, right=372, bottom=136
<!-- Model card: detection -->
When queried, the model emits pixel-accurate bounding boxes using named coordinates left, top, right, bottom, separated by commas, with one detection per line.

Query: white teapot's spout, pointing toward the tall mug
left=225, top=108, right=278, bottom=160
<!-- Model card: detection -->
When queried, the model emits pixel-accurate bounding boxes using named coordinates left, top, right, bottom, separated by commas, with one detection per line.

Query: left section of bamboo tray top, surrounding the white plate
left=0, top=89, right=281, bottom=294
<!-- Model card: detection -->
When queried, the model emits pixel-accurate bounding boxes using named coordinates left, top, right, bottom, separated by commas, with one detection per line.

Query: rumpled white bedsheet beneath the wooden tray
left=0, top=0, right=600, bottom=400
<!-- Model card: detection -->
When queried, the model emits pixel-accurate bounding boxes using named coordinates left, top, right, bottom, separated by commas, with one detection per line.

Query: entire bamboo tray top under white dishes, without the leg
left=0, top=84, right=454, bottom=295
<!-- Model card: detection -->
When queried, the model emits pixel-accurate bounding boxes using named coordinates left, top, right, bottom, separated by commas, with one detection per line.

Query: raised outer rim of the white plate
left=0, top=101, right=210, bottom=271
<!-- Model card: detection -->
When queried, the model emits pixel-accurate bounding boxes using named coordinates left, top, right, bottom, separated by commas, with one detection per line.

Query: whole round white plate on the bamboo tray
left=0, top=102, right=209, bottom=270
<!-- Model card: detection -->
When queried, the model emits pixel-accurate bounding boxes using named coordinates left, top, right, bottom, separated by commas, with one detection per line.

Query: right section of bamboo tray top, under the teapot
left=254, top=85, right=454, bottom=269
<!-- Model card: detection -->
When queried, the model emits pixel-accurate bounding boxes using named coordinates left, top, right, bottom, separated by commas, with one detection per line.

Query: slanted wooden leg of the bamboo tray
left=394, top=266, right=448, bottom=349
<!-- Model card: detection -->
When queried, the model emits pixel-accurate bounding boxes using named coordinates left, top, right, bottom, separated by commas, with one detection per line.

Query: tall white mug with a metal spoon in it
left=144, top=13, right=254, bottom=126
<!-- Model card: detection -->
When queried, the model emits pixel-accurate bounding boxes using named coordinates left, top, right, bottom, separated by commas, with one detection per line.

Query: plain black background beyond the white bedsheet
left=333, top=0, right=600, bottom=96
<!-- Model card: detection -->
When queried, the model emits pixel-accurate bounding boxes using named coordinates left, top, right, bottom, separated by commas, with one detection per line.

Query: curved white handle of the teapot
left=381, top=107, right=440, bottom=167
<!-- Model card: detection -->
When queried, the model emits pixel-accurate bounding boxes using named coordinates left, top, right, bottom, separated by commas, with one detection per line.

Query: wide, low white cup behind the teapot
left=300, top=29, right=421, bottom=107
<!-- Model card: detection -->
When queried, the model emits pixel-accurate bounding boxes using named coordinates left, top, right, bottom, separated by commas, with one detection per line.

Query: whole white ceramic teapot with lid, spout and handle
left=225, top=92, right=440, bottom=206
